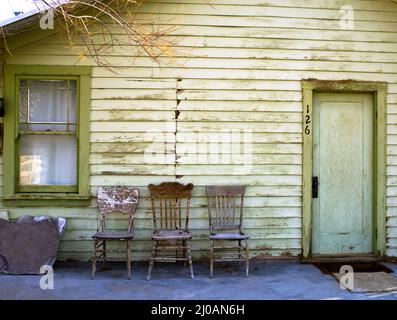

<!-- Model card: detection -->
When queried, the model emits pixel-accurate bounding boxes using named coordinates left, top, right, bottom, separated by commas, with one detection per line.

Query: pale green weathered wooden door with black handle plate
left=312, top=93, right=374, bottom=254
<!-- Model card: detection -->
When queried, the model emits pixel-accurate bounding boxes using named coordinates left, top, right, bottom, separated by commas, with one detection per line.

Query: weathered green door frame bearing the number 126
left=301, top=79, right=387, bottom=259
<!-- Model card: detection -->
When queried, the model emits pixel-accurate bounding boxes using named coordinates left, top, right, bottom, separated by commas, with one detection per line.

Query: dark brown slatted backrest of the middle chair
left=148, top=182, right=193, bottom=231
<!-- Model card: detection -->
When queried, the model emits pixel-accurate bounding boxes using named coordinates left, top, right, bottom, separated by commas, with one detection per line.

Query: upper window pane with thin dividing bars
left=19, top=80, right=77, bottom=131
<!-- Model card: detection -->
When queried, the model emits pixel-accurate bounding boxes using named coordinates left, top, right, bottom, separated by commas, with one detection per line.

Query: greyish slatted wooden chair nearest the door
left=206, top=186, right=249, bottom=278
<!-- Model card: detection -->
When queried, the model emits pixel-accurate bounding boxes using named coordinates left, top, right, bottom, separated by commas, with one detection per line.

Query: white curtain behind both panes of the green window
left=19, top=80, right=77, bottom=186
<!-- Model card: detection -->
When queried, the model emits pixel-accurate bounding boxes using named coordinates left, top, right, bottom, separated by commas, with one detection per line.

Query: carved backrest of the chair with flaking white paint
left=97, top=186, right=139, bottom=232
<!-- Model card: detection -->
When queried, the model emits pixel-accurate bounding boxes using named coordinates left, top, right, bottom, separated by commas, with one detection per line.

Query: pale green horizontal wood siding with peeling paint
left=2, top=0, right=397, bottom=260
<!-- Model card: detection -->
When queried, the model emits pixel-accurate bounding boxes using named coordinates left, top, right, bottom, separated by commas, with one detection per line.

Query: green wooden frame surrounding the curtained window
left=2, top=65, right=92, bottom=203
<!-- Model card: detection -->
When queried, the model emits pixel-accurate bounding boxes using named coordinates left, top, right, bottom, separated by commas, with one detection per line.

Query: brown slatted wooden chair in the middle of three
left=147, top=182, right=194, bottom=280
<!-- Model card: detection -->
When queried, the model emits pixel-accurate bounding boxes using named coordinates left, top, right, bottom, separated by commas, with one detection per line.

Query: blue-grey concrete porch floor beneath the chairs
left=0, top=260, right=397, bottom=300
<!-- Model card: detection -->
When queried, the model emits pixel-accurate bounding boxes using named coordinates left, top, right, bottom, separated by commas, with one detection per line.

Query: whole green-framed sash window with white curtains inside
left=3, top=65, right=91, bottom=200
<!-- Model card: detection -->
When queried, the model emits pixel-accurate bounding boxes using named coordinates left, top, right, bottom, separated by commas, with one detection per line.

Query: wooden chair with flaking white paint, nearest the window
left=91, top=186, right=139, bottom=279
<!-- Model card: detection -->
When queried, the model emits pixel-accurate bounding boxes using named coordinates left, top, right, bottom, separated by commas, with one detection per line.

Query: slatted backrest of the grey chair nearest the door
left=205, top=186, right=245, bottom=233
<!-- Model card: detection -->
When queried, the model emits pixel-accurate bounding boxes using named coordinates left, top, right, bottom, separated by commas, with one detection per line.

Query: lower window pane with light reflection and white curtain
left=19, top=135, right=77, bottom=186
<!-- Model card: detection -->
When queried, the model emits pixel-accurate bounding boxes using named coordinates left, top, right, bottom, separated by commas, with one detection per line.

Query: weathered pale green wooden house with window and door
left=0, top=0, right=397, bottom=261
